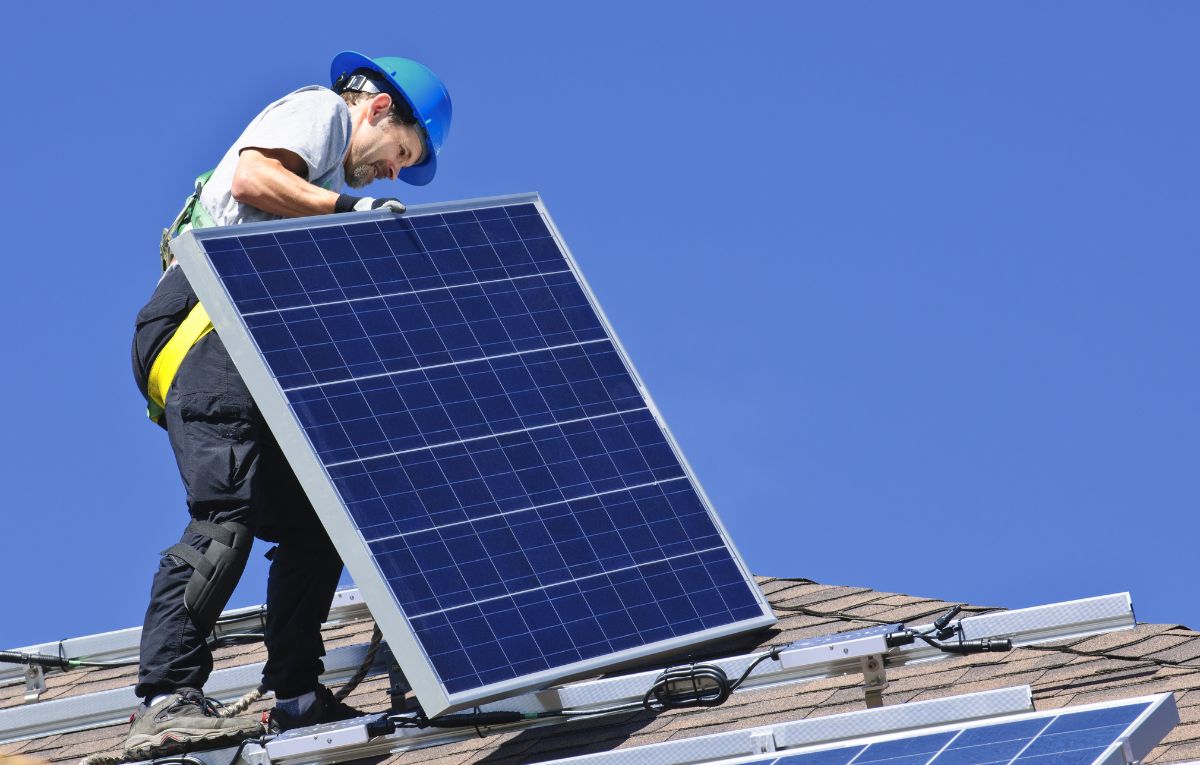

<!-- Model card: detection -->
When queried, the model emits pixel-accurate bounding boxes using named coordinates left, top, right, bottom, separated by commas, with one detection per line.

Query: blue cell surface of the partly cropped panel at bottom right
left=751, top=701, right=1150, bottom=765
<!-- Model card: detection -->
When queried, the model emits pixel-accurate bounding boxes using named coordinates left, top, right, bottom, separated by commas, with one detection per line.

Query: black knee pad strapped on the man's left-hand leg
left=163, top=520, right=254, bottom=632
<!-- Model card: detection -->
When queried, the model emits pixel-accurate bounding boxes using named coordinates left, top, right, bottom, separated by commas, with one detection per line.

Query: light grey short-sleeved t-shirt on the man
left=200, top=85, right=352, bottom=225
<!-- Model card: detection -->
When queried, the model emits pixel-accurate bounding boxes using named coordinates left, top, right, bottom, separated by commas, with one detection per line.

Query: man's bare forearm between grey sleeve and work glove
left=230, top=149, right=337, bottom=218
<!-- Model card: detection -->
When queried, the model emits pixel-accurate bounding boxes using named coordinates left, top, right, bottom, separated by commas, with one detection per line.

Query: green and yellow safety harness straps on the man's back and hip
left=146, top=170, right=215, bottom=423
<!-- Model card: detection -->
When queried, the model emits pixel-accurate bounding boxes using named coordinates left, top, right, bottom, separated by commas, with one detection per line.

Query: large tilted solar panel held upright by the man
left=172, top=194, right=774, bottom=713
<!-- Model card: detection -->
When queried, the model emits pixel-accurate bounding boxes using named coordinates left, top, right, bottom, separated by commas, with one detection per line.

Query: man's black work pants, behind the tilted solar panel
left=134, top=275, right=342, bottom=698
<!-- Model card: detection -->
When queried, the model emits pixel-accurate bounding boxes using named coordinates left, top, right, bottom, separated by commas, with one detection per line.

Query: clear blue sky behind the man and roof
left=0, top=1, right=1200, bottom=647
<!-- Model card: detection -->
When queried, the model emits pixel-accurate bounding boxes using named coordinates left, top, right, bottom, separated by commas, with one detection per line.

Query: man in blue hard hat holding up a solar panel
left=125, top=52, right=451, bottom=759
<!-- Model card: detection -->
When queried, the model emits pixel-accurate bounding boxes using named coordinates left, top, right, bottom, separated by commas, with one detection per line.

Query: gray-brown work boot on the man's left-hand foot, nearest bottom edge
left=125, top=688, right=263, bottom=760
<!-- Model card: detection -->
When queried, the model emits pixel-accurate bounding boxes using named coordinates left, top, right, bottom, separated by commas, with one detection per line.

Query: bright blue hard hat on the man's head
left=329, top=50, right=452, bottom=186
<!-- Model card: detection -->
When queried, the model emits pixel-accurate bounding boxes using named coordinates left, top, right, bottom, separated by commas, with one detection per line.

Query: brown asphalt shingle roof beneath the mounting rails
left=0, top=578, right=1200, bottom=765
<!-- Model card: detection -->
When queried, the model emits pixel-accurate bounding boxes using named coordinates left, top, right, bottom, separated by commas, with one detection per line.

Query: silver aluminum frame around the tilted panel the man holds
left=170, top=193, right=776, bottom=716
